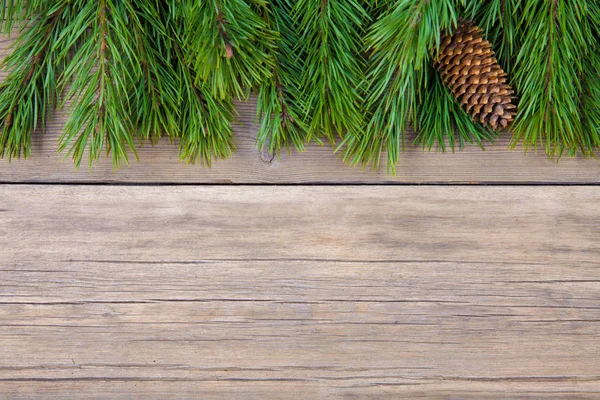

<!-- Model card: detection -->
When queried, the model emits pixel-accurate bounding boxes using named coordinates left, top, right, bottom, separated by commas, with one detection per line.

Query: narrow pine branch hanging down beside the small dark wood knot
left=256, top=0, right=308, bottom=155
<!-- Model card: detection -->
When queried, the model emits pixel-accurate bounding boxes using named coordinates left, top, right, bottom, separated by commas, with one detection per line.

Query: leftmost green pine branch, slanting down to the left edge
left=0, top=1, right=70, bottom=160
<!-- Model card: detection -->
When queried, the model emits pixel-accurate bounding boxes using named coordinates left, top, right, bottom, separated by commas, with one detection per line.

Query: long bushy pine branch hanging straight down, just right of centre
left=292, top=0, right=368, bottom=143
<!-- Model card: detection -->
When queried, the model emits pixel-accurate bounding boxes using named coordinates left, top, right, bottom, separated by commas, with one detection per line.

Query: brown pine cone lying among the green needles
left=435, top=22, right=517, bottom=130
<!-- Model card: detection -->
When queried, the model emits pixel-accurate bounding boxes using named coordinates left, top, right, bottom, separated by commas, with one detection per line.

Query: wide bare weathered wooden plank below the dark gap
left=0, top=185, right=600, bottom=400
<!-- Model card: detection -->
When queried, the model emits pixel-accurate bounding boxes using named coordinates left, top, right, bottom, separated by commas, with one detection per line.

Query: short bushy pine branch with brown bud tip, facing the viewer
left=182, top=0, right=274, bottom=99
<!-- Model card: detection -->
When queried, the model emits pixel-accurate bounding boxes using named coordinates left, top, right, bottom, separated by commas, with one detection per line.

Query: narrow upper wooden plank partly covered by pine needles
left=0, top=34, right=600, bottom=183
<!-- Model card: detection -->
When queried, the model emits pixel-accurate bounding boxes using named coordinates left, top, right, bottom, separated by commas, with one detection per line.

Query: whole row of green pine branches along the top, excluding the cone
left=0, top=0, right=600, bottom=172
